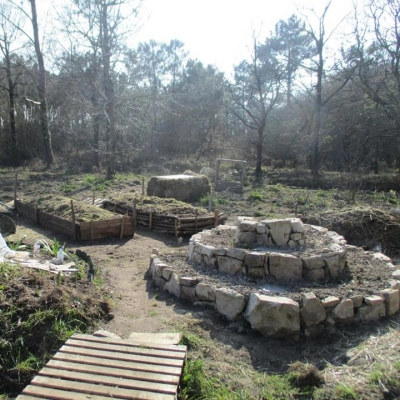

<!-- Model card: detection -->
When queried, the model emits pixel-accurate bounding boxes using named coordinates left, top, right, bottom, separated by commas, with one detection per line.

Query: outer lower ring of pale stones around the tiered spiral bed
left=149, top=253, right=400, bottom=338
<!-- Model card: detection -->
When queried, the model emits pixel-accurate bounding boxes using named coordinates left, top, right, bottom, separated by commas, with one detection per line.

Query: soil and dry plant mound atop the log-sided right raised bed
left=110, top=193, right=211, bottom=217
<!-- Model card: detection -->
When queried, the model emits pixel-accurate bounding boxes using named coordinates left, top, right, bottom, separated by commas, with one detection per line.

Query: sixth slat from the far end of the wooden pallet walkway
left=39, top=367, right=176, bottom=394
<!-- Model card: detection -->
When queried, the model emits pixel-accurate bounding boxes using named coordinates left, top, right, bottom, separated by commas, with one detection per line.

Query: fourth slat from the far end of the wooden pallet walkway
left=53, top=352, right=181, bottom=376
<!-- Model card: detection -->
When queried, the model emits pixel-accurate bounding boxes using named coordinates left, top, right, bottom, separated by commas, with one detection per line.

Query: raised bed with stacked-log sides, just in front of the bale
left=103, top=197, right=225, bottom=236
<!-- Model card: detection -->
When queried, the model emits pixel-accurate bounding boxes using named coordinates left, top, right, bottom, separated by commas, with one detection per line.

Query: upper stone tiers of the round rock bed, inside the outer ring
left=188, top=218, right=346, bottom=281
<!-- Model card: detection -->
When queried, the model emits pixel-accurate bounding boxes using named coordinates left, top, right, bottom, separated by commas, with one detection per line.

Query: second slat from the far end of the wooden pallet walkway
left=65, top=338, right=182, bottom=359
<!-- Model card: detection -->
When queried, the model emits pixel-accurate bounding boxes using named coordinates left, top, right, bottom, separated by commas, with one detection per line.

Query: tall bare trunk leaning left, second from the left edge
left=29, top=0, right=53, bottom=168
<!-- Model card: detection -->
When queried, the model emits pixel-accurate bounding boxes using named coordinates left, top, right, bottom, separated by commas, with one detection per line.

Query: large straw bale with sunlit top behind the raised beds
left=147, top=175, right=210, bottom=201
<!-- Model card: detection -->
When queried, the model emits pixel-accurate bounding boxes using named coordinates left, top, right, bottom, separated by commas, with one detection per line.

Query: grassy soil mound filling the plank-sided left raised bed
left=23, top=195, right=115, bottom=222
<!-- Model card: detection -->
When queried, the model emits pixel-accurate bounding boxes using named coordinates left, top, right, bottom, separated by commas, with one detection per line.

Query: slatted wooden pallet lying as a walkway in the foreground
left=17, top=334, right=186, bottom=400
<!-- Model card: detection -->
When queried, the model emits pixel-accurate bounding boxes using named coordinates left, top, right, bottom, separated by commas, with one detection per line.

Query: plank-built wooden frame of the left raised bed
left=15, top=199, right=134, bottom=240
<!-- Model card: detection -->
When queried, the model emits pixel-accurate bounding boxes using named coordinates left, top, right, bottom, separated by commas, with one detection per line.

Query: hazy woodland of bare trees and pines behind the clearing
left=0, top=0, right=400, bottom=183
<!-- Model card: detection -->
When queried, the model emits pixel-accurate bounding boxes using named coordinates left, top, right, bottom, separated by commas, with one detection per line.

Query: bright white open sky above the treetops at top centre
left=135, top=0, right=360, bottom=73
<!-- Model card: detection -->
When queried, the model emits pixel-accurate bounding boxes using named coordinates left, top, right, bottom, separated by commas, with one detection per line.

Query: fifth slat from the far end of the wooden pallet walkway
left=46, top=360, right=179, bottom=385
